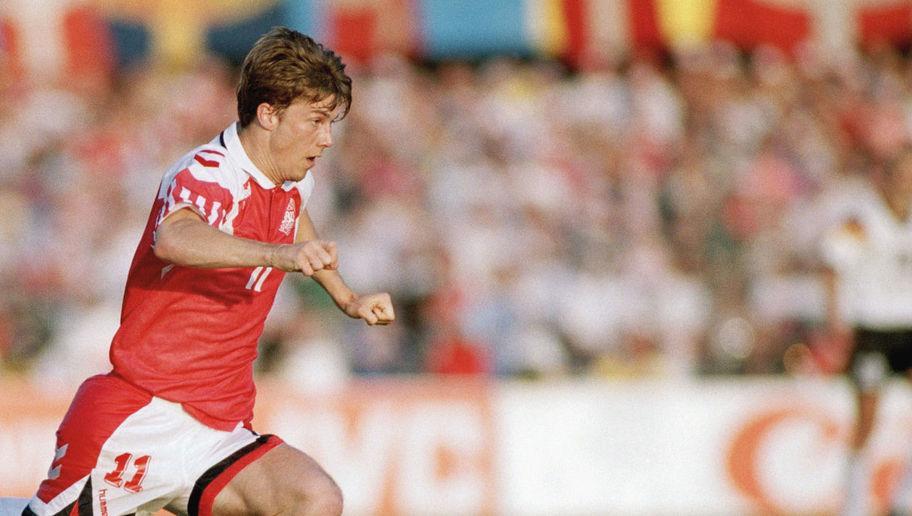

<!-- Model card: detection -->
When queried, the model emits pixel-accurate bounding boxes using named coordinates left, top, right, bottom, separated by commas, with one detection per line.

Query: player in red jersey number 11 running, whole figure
left=23, top=28, right=395, bottom=516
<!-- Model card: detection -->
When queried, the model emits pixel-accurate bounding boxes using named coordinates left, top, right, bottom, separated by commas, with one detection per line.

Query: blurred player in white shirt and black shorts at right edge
left=822, top=147, right=912, bottom=516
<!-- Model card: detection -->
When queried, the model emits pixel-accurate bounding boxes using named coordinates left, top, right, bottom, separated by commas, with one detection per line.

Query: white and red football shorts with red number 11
left=23, top=375, right=282, bottom=516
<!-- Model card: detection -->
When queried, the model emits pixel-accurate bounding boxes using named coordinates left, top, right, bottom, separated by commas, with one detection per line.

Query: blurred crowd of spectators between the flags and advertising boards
left=0, top=44, right=912, bottom=387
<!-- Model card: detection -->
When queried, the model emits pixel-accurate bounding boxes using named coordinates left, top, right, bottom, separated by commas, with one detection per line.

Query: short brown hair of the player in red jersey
left=237, top=27, right=351, bottom=127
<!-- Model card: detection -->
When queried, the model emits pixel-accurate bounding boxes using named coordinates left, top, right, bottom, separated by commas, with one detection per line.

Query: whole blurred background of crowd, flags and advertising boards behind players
left=0, top=0, right=912, bottom=514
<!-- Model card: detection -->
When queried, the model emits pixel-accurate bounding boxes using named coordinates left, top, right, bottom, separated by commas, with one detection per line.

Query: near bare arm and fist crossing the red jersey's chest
left=154, top=208, right=338, bottom=276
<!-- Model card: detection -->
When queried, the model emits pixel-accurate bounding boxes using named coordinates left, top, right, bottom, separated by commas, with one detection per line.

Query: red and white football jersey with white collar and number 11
left=110, top=124, right=314, bottom=430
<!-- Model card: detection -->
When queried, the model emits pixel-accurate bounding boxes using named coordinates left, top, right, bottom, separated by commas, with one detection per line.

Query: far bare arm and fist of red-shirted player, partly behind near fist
left=295, top=209, right=396, bottom=326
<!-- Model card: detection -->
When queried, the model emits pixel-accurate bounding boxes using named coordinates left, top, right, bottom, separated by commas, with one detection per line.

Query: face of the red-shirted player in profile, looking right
left=269, top=97, right=342, bottom=181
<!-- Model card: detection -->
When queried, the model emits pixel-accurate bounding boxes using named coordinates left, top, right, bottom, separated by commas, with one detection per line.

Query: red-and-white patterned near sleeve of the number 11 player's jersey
left=155, top=151, right=236, bottom=228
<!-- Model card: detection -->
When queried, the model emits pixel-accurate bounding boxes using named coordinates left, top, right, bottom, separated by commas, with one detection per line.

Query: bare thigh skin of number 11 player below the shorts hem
left=212, top=443, right=342, bottom=516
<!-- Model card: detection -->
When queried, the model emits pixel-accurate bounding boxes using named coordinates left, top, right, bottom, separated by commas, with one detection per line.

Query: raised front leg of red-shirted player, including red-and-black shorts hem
left=188, top=436, right=342, bottom=516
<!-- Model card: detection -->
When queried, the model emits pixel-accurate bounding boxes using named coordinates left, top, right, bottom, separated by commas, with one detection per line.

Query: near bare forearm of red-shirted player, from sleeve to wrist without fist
left=154, top=218, right=279, bottom=268
